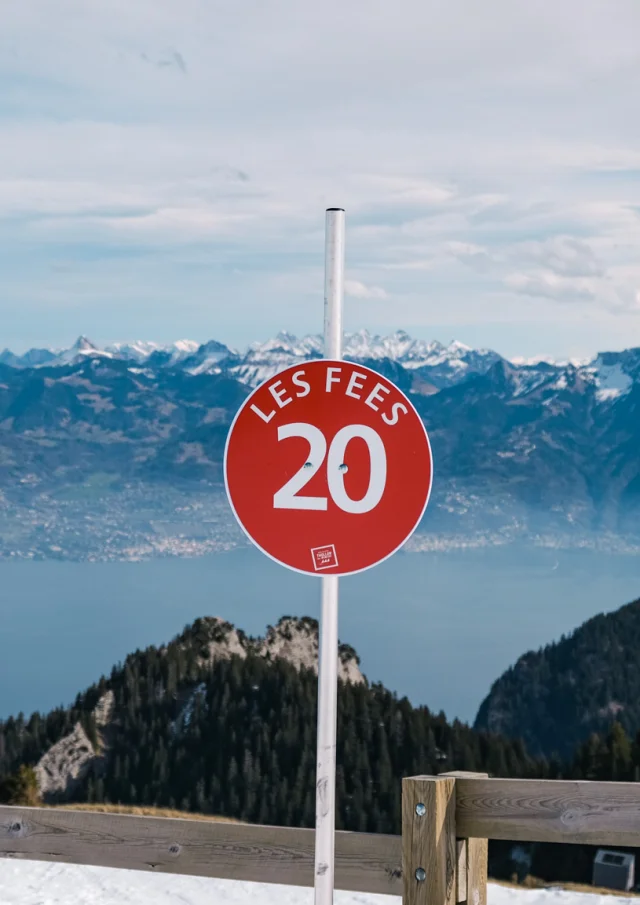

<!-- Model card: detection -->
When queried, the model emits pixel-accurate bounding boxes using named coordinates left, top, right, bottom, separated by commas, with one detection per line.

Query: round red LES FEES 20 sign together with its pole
left=224, top=208, right=433, bottom=905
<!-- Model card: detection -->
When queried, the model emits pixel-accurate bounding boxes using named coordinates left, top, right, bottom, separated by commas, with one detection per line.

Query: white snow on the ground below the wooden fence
left=0, top=860, right=637, bottom=905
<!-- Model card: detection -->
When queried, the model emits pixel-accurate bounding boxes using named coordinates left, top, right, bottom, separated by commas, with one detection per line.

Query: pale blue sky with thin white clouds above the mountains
left=0, top=0, right=640, bottom=358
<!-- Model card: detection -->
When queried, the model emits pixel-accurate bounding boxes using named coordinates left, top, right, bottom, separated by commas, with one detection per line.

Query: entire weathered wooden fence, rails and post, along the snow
left=0, top=773, right=640, bottom=905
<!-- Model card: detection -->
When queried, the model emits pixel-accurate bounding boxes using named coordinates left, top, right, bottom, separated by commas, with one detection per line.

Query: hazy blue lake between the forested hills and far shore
left=0, top=547, right=640, bottom=720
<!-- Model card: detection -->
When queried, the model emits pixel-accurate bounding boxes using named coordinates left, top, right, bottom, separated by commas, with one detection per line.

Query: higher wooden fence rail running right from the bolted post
left=456, top=778, right=640, bottom=847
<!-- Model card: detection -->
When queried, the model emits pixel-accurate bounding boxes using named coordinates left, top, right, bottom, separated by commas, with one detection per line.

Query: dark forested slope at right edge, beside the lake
left=475, top=600, right=640, bottom=760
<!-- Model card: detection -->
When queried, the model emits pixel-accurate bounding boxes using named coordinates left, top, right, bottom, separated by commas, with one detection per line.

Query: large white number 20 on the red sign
left=273, top=422, right=387, bottom=515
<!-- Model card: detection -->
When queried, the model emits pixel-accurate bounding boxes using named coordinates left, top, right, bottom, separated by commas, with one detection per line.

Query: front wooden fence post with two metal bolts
left=402, top=776, right=457, bottom=905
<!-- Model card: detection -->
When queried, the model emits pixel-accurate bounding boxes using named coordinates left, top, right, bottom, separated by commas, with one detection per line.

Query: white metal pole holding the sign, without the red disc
left=315, top=208, right=344, bottom=905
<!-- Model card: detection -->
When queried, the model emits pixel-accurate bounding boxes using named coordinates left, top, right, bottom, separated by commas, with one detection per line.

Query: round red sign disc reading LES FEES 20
left=224, top=360, right=433, bottom=575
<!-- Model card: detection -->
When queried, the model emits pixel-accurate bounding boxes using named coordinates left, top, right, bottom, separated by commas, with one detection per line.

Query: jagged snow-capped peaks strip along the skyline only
left=0, top=330, right=640, bottom=402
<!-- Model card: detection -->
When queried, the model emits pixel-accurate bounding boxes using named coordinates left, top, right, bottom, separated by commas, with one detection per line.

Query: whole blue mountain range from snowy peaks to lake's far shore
left=0, top=332, right=640, bottom=558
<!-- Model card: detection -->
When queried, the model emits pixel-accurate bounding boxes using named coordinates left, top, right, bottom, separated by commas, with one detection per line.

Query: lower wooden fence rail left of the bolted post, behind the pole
left=0, top=807, right=402, bottom=895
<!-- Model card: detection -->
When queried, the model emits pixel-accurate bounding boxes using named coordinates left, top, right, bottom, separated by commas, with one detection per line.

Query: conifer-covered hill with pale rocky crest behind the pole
left=0, top=620, right=548, bottom=832
